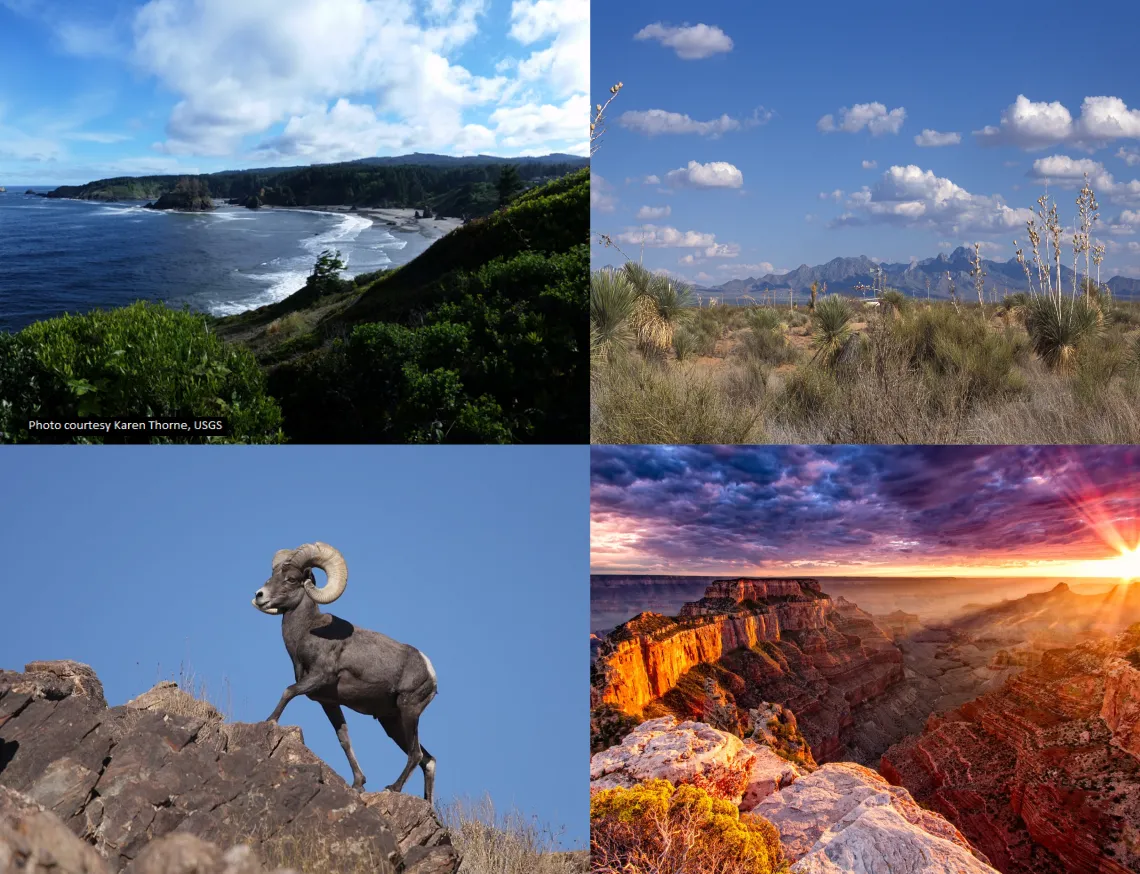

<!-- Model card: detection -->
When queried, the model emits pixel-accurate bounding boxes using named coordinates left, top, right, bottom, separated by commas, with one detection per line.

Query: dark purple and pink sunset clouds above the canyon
left=592, top=447, right=1140, bottom=574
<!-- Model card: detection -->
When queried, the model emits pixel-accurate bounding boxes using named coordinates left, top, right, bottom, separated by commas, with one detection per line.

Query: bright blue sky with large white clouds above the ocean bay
left=0, top=0, right=589, bottom=187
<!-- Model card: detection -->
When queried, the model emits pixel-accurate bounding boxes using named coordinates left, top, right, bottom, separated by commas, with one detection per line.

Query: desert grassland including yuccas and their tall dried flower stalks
left=591, top=181, right=1140, bottom=443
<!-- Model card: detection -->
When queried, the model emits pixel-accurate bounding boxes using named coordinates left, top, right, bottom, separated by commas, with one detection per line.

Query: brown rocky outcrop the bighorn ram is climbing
left=0, top=661, right=461, bottom=874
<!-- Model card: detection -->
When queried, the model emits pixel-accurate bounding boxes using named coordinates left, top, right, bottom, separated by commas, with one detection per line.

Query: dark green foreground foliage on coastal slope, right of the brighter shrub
left=271, top=243, right=588, bottom=443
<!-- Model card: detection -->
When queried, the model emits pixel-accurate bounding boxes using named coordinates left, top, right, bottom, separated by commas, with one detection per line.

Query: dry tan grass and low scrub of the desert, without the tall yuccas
left=591, top=284, right=1140, bottom=443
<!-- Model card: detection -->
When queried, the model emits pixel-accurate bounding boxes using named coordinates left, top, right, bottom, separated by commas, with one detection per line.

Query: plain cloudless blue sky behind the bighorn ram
left=0, top=447, right=589, bottom=846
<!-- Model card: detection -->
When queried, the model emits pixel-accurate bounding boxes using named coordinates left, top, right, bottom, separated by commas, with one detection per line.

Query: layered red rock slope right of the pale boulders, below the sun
left=880, top=628, right=1140, bottom=874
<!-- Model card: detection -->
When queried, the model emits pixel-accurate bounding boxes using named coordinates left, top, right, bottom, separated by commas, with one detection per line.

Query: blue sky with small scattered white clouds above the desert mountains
left=591, top=0, right=1140, bottom=285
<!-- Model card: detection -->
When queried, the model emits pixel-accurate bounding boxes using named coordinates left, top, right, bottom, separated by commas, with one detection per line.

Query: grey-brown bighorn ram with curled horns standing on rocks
left=253, top=544, right=437, bottom=801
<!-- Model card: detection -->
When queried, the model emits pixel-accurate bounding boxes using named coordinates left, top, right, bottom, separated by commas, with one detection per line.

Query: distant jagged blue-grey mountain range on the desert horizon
left=698, top=246, right=1140, bottom=301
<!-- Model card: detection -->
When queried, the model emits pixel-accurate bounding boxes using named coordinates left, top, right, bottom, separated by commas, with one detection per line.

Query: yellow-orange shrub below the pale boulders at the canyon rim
left=589, top=779, right=783, bottom=874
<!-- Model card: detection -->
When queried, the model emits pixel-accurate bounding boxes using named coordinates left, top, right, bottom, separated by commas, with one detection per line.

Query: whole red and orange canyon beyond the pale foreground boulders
left=591, top=578, right=1140, bottom=874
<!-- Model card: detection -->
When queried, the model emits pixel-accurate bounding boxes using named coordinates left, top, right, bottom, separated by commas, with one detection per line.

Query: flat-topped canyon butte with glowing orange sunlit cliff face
left=593, top=578, right=904, bottom=761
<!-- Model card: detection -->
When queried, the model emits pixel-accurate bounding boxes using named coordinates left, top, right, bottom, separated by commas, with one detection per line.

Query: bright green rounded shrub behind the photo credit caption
left=0, top=302, right=283, bottom=443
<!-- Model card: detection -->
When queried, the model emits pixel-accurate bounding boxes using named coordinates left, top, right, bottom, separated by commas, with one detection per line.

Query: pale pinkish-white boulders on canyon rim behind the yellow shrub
left=591, top=717, right=995, bottom=874
